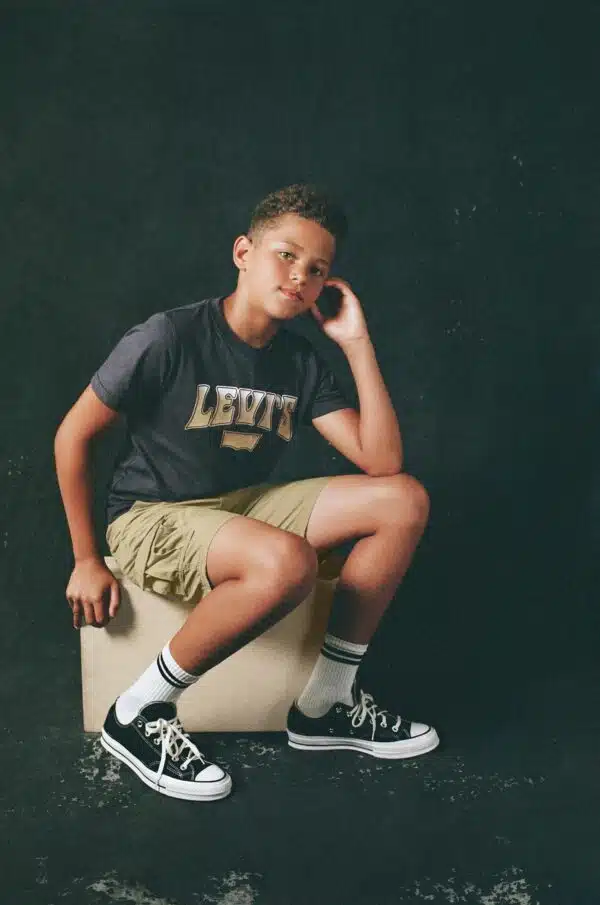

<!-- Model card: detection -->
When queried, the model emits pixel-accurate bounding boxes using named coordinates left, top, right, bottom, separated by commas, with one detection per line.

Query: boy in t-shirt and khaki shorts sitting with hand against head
left=55, top=185, right=439, bottom=801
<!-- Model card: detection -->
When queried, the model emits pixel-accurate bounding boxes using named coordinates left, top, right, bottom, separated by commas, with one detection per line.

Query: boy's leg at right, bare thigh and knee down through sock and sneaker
left=288, top=474, right=439, bottom=757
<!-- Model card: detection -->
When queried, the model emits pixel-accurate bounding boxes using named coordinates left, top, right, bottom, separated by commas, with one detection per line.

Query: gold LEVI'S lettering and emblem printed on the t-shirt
left=185, top=383, right=298, bottom=452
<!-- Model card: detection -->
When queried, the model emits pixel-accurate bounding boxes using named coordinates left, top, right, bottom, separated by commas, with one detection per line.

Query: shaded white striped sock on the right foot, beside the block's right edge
left=296, top=633, right=368, bottom=717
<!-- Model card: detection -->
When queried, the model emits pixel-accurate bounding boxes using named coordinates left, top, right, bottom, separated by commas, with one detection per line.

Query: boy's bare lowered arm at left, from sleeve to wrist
left=54, top=386, right=119, bottom=565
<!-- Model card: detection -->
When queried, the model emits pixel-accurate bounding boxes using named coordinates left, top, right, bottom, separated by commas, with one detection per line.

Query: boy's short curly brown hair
left=247, top=183, right=348, bottom=243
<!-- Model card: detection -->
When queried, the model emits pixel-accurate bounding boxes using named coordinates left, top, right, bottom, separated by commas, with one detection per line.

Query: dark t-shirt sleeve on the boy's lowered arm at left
left=90, top=312, right=174, bottom=416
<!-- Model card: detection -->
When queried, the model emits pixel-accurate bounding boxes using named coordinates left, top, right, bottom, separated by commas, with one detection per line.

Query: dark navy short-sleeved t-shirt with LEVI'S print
left=90, top=296, right=351, bottom=524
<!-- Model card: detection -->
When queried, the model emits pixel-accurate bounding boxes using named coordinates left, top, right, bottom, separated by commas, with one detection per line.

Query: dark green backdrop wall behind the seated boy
left=0, top=2, right=600, bottom=730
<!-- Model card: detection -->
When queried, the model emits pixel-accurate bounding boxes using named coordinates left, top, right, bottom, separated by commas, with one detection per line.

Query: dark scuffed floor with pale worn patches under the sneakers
left=0, top=656, right=600, bottom=905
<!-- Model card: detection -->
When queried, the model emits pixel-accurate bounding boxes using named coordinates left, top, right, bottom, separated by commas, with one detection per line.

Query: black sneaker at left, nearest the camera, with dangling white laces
left=100, top=702, right=232, bottom=801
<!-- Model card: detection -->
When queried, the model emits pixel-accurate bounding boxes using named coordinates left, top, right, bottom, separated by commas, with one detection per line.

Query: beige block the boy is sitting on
left=80, top=556, right=339, bottom=732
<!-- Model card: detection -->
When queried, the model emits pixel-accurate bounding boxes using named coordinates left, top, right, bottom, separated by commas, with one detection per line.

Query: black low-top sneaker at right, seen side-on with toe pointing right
left=287, top=682, right=440, bottom=758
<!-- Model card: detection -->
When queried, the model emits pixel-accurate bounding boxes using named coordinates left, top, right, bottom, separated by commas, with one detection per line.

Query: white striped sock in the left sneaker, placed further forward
left=116, top=644, right=200, bottom=723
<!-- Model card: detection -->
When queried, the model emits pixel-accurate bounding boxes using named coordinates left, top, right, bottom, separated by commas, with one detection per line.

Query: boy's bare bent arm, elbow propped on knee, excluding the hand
left=312, top=336, right=403, bottom=477
